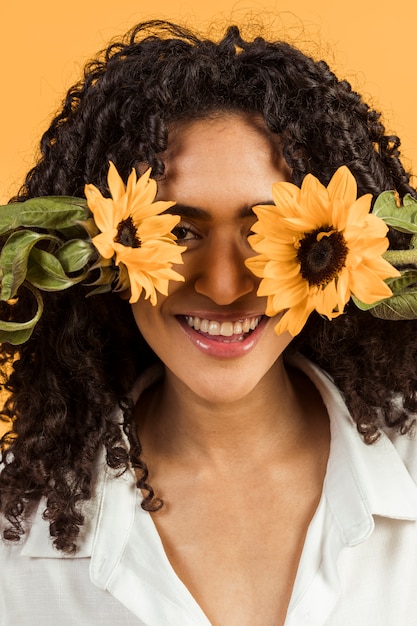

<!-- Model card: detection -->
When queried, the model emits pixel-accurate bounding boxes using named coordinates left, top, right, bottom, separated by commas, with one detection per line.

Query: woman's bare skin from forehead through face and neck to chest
left=128, top=113, right=328, bottom=626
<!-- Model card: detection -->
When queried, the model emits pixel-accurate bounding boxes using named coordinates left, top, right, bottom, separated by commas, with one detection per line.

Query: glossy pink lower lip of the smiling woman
left=177, top=316, right=267, bottom=359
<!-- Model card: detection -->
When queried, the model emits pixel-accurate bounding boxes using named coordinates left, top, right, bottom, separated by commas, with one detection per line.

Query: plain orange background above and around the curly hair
left=0, top=0, right=417, bottom=202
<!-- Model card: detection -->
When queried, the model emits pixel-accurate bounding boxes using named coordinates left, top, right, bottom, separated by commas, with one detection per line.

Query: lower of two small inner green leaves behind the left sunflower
left=26, top=248, right=88, bottom=291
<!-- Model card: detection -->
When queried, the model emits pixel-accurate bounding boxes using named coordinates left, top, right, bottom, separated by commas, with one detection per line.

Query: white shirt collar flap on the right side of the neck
left=294, top=357, right=417, bottom=546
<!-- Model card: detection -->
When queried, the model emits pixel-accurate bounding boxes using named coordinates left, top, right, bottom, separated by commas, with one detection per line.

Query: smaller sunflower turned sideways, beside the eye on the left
left=85, top=163, right=185, bottom=305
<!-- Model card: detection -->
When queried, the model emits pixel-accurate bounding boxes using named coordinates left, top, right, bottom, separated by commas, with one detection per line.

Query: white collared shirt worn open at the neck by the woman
left=0, top=360, right=417, bottom=626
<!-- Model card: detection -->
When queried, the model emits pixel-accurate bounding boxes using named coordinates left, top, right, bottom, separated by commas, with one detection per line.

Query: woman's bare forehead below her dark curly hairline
left=158, top=113, right=290, bottom=197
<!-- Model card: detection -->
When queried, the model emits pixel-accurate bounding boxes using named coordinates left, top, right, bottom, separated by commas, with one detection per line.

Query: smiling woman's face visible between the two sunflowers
left=132, top=114, right=291, bottom=402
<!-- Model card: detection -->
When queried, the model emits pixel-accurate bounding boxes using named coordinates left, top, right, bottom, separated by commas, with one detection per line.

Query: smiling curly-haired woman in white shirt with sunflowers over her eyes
left=0, top=21, right=417, bottom=626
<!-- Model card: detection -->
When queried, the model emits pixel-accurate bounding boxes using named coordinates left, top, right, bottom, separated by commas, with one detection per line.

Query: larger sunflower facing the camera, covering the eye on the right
left=246, top=166, right=400, bottom=336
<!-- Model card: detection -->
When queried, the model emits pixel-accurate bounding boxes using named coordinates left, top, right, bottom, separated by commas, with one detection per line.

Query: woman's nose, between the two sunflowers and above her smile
left=194, top=239, right=258, bottom=306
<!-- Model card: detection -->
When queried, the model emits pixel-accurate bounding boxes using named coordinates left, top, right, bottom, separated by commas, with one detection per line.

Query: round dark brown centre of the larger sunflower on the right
left=297, top=226, right=348, bottom=286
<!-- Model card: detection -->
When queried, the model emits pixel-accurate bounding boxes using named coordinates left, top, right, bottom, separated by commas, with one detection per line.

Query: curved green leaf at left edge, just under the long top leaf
left=0, top=230, right=60, bottom=300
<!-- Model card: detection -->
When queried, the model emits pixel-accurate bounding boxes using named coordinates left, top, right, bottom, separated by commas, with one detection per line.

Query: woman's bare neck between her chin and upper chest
left=135, top=359, right=320, bottom=466
